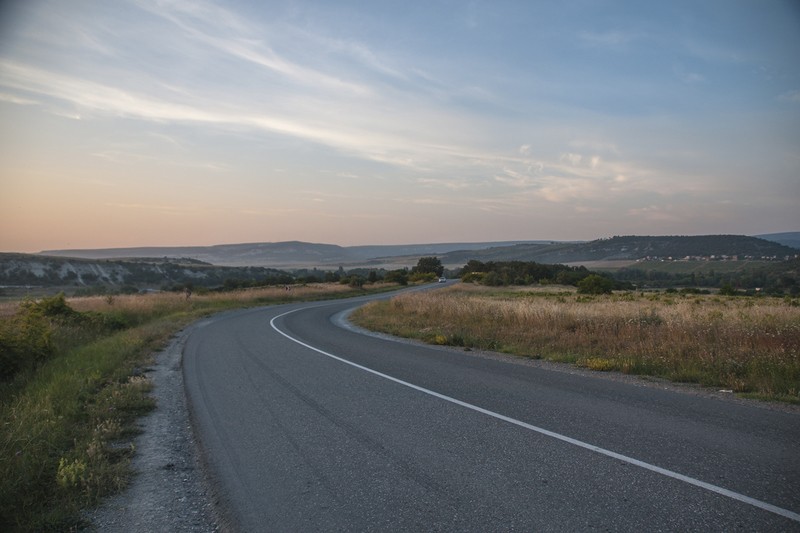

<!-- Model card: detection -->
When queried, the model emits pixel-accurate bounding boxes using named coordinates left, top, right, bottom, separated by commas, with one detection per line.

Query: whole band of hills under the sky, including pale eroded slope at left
left=0, top=235, right=800, bottom=290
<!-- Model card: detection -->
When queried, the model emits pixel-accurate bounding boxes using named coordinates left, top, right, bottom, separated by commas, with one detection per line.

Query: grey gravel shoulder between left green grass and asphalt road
left=85, top=327, right=220, bottom=533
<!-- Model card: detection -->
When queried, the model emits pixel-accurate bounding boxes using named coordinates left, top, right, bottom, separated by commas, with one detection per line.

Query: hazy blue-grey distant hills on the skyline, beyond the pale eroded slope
left=25, top=234, right=800, bottom=270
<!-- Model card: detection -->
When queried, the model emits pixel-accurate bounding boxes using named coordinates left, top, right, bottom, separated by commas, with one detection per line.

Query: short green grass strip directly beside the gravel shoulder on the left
left=0, top=317, right=186, bottom=531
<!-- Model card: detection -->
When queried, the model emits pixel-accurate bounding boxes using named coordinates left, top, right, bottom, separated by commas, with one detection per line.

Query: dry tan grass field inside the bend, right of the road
left=353, top=284, right=800, bottom=403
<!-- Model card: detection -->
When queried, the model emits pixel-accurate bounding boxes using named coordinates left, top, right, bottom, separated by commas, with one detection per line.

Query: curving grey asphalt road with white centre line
left=183, top=284, right=800, bottom=531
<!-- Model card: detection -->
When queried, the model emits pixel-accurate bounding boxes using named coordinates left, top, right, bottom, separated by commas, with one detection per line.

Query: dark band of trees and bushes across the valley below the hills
left=0, top=257, right=800, bottom=296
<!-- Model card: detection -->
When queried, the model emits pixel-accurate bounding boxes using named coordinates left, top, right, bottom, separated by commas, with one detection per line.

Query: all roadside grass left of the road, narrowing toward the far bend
left=0, top=280, right=396, bottom=532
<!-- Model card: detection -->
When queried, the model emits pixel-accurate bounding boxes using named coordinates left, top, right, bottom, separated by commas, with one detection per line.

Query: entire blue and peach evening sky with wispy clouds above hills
left=0, top=0, right=800, bottom=252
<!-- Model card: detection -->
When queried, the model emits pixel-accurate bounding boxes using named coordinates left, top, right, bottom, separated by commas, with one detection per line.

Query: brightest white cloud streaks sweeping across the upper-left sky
left=0, top=0, right=636, bottom=189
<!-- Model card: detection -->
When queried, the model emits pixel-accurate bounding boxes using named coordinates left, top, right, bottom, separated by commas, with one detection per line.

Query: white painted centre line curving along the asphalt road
left=269, top=308, right=800, bottom=522
